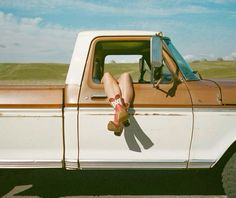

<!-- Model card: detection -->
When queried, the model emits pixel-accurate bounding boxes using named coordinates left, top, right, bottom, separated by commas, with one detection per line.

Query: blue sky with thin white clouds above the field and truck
left=0, top=0, right=236, bottom=63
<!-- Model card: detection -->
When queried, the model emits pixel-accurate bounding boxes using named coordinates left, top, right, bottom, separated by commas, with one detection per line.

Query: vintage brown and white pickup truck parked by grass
left=0, top=31, right=236, bottom=195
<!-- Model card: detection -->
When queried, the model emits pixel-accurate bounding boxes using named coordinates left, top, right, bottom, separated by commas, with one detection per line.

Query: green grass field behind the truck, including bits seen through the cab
left=0, top=61, right=236, bottom=84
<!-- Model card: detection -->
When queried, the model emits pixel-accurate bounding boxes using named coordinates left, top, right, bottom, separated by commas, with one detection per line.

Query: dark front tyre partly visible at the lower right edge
left=222, top=153, right=236, bottom=197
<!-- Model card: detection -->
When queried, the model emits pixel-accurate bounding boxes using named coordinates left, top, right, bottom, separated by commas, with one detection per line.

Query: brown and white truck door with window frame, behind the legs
left=78, top=36, right=193, bottom=168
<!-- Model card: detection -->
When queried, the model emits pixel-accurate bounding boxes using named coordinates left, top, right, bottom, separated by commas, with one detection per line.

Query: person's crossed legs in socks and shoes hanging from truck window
left=101, top=72, right=134, bottom=134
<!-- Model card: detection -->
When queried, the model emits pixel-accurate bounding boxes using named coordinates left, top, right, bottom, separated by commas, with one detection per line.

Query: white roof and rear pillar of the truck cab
left=66, top=30, right=157, bottom=86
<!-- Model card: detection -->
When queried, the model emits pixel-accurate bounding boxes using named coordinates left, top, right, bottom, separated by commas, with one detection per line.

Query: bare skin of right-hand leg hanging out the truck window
left=118, top=73, right=134, bottom=106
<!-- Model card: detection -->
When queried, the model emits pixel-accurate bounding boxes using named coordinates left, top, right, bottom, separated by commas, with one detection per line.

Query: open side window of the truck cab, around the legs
left=92, top=40, right=173, bottom=84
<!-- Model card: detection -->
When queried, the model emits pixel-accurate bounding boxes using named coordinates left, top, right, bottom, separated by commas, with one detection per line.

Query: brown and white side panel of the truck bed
left=0, top=86, right=64, bottom=168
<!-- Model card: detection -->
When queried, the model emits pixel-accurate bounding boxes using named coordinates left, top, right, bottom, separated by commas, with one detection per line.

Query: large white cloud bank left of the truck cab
left=0, top=12, right=78, bottom=63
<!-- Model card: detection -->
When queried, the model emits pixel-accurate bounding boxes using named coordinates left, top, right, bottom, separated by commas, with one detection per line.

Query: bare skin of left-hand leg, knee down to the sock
left=101, top=72, right=121, bottom=98
